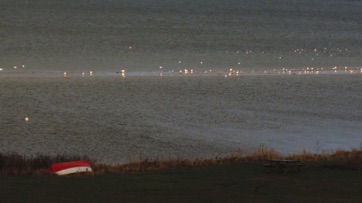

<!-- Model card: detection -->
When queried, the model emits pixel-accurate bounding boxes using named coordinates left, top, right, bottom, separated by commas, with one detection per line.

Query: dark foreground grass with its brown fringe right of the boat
left=0, top=150, right=362, bottom=202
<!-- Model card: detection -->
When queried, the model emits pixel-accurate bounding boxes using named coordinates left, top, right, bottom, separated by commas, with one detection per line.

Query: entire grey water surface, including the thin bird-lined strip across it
left=0, top=0, right=362, bottom=163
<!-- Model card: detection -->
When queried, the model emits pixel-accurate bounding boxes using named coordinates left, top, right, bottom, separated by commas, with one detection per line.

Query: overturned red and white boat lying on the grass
left=49, top=160, right=93, bottom=175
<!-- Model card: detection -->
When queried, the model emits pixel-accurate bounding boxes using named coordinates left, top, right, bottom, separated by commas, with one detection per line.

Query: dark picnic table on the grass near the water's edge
left=264, top=159, right=304, bottom=174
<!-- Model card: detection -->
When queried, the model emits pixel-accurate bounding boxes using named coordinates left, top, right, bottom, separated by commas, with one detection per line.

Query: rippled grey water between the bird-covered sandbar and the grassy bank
left=0, top=74, right=362, bottom=163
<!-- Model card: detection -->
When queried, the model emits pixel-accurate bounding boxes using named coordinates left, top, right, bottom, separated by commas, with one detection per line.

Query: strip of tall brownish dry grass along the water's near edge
left=0, top=146, right=362, bottom=175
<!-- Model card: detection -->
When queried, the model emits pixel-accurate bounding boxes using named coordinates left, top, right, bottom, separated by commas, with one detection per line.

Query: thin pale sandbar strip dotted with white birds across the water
left=0, top=67, right=362, bottom=78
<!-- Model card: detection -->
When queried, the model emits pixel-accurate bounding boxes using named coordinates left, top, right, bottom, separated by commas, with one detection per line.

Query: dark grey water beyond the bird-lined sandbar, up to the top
left=0, top=0, right=362, bottom=72
